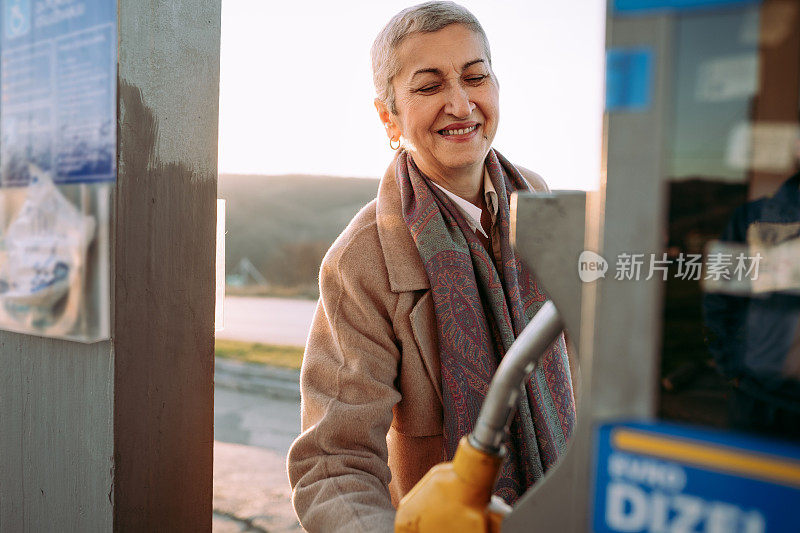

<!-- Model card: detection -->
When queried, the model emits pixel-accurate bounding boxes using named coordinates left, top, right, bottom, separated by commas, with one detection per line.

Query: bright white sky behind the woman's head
left=219, top=0, right=605, bottom=189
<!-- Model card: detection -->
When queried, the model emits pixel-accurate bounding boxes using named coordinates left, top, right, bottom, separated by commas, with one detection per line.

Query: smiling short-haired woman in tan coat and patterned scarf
left=288, top=2, right=575, bottom=531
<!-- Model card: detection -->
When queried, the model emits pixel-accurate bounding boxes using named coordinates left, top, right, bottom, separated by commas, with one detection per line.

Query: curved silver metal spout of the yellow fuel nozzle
left=468, top=301, right=564, bottom=455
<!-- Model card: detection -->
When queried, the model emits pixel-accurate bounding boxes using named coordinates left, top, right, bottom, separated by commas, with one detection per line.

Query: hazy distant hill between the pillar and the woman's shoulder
left=217, top=174, right=378, bottom=293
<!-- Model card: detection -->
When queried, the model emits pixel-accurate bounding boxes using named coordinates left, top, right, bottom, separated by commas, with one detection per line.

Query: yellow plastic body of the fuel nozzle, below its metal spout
left=394, top=437, right=505, bottom=533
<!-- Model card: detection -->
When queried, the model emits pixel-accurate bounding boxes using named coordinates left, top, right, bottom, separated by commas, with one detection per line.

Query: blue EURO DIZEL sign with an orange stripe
left=592, top=423, right=800, bottom=533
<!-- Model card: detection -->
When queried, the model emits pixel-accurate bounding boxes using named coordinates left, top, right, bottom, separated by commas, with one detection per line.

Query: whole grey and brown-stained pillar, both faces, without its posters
left=0, top=0, right=220, bottom=532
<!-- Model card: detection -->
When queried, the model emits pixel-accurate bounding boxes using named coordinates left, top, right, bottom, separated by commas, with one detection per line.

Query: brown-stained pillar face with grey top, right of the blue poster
left=113, top=0, right=220, bottom=531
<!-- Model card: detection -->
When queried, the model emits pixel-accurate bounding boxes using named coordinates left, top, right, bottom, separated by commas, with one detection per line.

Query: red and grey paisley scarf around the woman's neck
left=395, top=149, right=575, bottom=504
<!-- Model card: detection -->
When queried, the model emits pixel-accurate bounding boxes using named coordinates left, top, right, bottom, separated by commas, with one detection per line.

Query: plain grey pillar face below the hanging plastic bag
left=0, top=331, right=114, bottom=532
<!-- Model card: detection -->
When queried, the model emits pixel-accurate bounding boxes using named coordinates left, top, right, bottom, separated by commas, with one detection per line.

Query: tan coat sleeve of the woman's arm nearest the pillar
left=287, top=223, right=400, bottom=532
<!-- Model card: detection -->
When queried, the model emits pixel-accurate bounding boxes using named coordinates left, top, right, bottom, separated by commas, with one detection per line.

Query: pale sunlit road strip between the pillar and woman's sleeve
left=217, top=296, right=317, bottom=346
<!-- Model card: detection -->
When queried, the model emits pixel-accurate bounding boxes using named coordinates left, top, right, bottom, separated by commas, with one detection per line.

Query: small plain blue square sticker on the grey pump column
left=606, top=48, right=653, bottom=111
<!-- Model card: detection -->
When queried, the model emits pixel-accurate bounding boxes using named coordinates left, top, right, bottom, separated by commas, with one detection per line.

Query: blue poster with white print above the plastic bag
left=0, top=0, right=117, bottom=186
